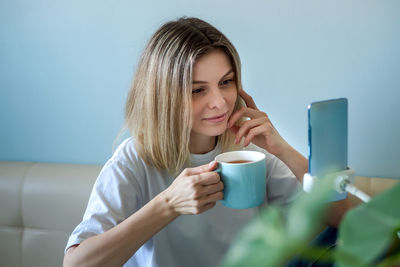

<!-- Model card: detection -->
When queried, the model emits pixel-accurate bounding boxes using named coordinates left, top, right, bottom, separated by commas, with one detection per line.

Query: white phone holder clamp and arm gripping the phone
left=303, top=168, right=371, bottom=202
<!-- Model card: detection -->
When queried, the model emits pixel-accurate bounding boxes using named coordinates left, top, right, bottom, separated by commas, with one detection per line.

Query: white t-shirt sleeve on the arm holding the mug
left=65, top=159, right=142, bottom=251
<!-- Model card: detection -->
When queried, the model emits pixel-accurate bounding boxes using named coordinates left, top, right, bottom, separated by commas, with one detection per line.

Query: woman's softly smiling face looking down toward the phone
left=191, top=50, right=237, bottom=142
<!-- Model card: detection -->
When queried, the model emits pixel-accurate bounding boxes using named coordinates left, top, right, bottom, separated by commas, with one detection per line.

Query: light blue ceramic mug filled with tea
left=215, top=150, right=267, bottom=209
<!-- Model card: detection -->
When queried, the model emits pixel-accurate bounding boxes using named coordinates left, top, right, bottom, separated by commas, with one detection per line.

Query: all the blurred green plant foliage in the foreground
left=221, top=179, right=400, bottom=267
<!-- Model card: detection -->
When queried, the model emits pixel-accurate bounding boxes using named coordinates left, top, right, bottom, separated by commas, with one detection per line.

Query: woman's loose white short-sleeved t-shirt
left=66, top=138, right=300, bottom=267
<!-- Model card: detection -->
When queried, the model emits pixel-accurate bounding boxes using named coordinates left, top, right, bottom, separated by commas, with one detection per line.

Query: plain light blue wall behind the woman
left=0, top=0, right=400, bottom=177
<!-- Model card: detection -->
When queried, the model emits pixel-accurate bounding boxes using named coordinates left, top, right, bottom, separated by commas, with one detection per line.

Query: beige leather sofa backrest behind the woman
left=0, top=161, right=398, bottom=267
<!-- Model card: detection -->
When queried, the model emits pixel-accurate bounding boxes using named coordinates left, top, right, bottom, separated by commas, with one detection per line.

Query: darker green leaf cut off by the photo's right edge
left=336, top=183, right=400, bottom=266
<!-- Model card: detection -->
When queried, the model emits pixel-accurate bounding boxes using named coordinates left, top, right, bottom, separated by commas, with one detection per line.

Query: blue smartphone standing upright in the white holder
left=308, top=98, right=348, bottom=201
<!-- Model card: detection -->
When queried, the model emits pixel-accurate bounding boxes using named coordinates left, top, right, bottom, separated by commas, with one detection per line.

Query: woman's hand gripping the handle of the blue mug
left=163, top=161, right=224, bottom=215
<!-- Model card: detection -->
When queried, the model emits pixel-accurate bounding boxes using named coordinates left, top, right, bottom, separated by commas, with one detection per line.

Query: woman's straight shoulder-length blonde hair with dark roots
left=125, top=17, right=243, bottom=175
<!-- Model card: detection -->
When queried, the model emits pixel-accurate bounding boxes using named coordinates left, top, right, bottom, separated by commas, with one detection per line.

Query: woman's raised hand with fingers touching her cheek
left=228, top=89, right=289, bottom=156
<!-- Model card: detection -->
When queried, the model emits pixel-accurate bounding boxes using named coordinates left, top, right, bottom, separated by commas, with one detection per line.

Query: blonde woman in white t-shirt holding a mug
left=64, top=18, right=350, bottom=266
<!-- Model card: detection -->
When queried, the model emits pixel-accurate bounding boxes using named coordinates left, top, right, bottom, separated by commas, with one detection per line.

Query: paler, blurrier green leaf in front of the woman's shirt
left=222, top=179, right=333, bottom=267
